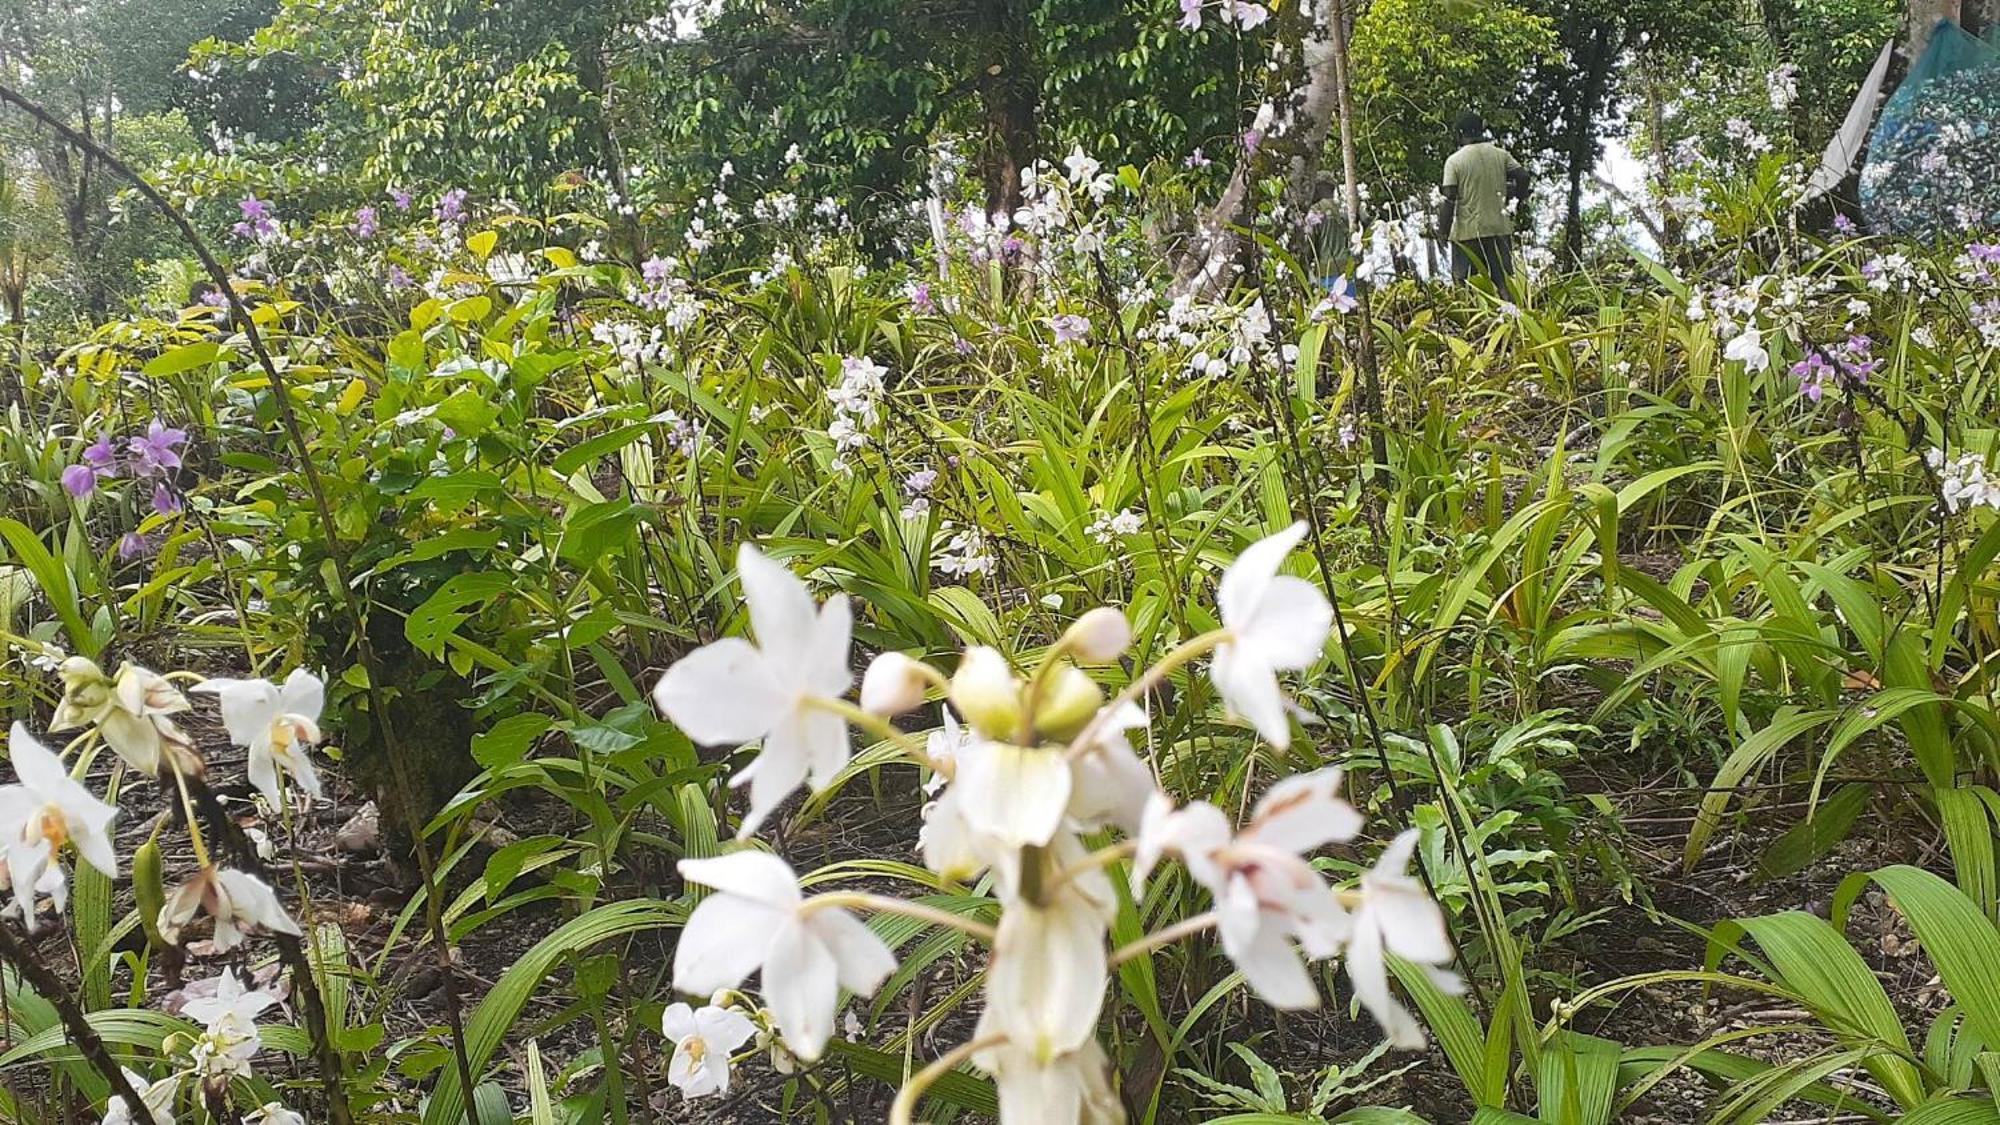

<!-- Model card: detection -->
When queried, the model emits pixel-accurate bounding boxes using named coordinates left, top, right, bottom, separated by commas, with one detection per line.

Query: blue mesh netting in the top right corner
left=1862, top=22, right=2000, bottom=238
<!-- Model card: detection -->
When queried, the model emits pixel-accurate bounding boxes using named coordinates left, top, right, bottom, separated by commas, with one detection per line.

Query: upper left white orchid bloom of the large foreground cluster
left=652, top=542, right=854, bottom=839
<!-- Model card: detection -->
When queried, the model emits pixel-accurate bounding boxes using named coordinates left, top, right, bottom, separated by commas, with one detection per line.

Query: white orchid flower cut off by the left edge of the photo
left=0, top=723, right=118, bottom=931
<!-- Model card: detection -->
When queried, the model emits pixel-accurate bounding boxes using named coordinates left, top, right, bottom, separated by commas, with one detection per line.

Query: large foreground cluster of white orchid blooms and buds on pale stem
left=654, top=524, right=1458, bottom=1125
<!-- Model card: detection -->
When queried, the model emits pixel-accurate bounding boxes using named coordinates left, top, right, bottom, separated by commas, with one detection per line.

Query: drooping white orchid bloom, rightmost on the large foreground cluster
left=1348, top=829, right=1462, bottom=1051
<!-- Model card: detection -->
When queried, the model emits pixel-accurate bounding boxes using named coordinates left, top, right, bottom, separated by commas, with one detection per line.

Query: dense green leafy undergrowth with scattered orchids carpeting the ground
left=0, top=136, right=2000, bottom=1125
